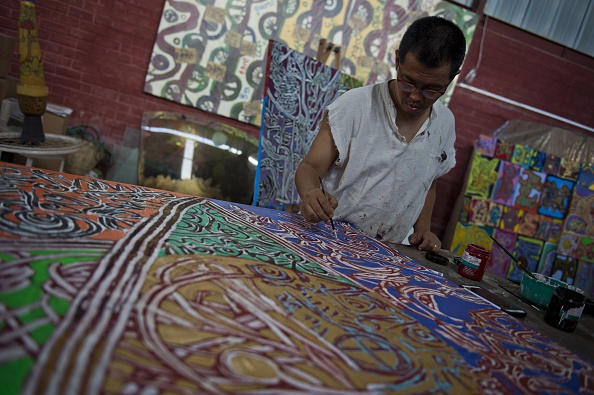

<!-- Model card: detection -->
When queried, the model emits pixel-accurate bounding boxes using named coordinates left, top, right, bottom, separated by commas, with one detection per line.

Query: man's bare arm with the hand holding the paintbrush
left=295, top=111, right=338, bottom=222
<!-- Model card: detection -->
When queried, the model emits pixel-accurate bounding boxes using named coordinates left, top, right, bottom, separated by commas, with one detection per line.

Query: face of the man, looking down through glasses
left=396, top=51, right=451, bottom=117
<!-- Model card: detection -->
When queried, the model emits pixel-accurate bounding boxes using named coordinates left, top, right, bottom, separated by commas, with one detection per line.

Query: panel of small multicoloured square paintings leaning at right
left=451, top=135, right=594, bottom=298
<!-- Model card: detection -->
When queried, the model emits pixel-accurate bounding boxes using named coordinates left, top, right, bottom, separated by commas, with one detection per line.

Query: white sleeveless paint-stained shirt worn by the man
left=324, top=81, right=456, bottom=243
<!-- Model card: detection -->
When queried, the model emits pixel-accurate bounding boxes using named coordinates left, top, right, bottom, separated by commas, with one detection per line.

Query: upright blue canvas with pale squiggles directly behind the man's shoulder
left=253, top=40, right=362, bottom=209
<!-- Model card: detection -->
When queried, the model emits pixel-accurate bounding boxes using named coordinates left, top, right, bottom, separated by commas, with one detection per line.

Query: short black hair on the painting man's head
left=398, top=16, right=466, bottom=78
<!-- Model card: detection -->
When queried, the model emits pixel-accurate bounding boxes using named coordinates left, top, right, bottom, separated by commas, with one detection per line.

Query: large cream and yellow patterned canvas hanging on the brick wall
left=144, top=0, right=478, bottom=125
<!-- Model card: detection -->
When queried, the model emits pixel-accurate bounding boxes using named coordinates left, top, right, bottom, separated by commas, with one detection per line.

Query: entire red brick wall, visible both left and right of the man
left=0, top=0, right=594, bottom=241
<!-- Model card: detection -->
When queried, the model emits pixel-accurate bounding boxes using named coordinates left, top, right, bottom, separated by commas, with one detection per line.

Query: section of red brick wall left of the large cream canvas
left=0, top=0, right=259, bottom=141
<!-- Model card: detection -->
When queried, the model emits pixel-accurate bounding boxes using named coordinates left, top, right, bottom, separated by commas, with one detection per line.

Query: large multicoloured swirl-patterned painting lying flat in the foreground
left=0, top=163, right=594, bottom=394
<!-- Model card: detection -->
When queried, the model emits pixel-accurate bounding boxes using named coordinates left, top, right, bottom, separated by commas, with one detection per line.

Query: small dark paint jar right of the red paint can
left=544, top=286, right=586, bottom=332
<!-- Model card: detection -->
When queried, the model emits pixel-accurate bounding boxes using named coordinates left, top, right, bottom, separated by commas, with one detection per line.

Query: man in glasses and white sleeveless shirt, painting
left=295, top=17, right=466, bottom=251
